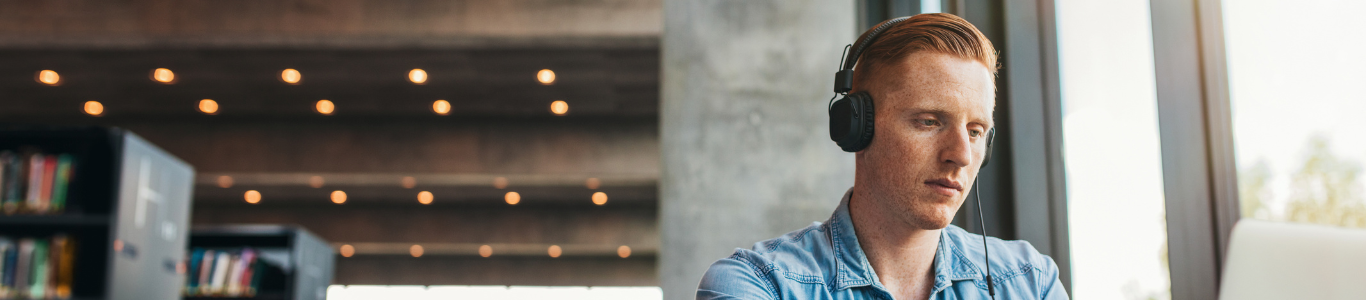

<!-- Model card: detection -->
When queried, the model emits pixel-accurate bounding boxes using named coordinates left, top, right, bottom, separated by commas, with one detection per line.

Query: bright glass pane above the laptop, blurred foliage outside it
left=1224, top=0, right=1366, bottom=228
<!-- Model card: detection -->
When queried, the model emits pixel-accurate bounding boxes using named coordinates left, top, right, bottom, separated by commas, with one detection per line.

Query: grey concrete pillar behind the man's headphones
left=658, top=0, right=856, bottom=300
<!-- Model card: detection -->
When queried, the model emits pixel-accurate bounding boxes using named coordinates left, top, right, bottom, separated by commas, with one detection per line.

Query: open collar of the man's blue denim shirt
left=826, top=188, right=982, bottom=293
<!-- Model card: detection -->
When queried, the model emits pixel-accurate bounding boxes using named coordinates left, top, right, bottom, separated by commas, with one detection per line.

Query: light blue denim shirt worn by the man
left=697, top=190, right=1067, bottom=300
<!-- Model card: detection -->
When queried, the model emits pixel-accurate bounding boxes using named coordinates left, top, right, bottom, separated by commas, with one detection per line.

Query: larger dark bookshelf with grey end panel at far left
left=0, top=125, right=194, bottom=300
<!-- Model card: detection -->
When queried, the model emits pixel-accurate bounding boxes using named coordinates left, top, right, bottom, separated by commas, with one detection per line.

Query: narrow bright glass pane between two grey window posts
left=1054, top=0, right=1171, bottom=299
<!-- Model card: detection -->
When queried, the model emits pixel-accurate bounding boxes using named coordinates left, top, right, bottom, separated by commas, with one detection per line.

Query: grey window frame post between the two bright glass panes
left=1150, top=0, right=1240, bottom=300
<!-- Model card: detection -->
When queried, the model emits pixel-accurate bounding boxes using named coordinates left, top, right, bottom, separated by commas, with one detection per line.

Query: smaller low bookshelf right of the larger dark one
left=184, top=225, right=336, bottom=300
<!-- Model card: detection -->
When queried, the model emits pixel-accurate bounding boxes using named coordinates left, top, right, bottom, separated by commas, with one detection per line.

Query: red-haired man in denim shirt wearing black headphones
left=697, top=14, right=1067, bottom=300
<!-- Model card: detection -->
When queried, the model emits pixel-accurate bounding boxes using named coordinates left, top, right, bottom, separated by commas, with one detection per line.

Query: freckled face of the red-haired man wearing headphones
left=855, top=52, right=996, bottom=229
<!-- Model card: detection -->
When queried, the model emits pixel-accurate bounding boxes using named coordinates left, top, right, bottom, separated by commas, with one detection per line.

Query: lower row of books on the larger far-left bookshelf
left=0, top=235, right=75, bottom=299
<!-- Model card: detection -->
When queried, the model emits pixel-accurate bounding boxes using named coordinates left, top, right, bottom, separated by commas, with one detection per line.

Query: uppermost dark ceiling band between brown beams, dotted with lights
left=0, top=48, right=658, bottom=120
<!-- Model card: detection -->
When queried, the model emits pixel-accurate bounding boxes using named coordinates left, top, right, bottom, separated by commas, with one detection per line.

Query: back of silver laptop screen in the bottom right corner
left=1218, top=220, right=1366, bottom=300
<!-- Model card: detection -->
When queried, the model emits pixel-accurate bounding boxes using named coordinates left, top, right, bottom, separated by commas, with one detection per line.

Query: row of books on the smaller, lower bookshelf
left=184, top=247, right=265, bottom=297
